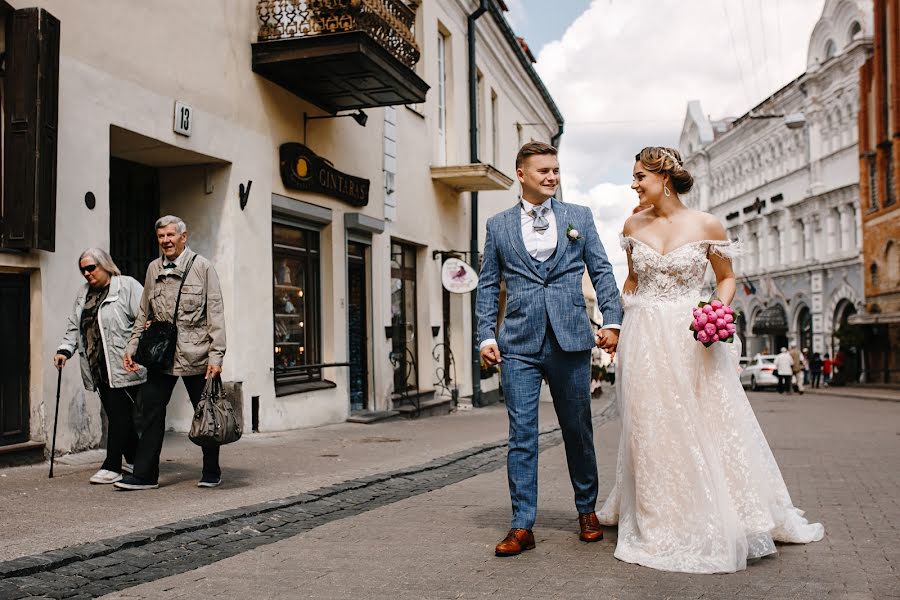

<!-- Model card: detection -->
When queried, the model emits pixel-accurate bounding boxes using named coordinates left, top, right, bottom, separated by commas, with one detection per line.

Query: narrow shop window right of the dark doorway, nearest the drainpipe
left=391, top=241, right=419, bottom=394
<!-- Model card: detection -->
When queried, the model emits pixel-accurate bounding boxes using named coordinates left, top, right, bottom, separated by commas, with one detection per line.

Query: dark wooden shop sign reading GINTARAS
left=279, top=142, right=369, bottom=206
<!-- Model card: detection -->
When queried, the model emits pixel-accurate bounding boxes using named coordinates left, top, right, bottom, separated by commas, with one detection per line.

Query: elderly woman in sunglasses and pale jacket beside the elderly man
left=53, top=248, right=147, bottom=484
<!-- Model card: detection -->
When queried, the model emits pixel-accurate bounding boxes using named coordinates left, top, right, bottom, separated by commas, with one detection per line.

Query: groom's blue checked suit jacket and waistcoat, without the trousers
left=476, top=198, right=622, bottom=354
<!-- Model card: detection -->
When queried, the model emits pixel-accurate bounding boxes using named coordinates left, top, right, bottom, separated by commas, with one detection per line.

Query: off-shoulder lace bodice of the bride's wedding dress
left=620, top=236, right=739, bottom=301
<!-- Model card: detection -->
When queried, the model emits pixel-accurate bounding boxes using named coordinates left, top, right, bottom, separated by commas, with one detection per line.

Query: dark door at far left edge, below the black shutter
left=0, top=274, right=30, bottom=446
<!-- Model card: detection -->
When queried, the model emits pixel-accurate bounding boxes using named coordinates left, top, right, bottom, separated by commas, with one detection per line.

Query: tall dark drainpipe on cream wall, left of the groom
left=467, top=0, right=490, bottom=406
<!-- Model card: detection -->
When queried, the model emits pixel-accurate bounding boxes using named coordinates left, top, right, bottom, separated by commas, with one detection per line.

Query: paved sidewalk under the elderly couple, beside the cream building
left=0, top=382, right=584, bottom=561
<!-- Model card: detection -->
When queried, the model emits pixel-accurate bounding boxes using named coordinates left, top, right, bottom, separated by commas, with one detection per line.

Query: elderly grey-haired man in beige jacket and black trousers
left=114, top=215, right=225, bottom=490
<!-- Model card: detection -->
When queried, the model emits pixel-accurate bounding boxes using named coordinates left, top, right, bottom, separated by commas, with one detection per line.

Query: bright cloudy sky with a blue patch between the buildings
left=506, top=0, right=824, bottom=284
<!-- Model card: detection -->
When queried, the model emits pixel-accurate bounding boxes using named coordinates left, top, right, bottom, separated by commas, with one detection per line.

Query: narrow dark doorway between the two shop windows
left=347, top=242, right=369, bottom=410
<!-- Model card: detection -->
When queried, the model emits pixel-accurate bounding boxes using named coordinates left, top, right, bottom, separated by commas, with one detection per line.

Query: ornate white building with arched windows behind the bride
left=680, top=0, right=872, bottom=368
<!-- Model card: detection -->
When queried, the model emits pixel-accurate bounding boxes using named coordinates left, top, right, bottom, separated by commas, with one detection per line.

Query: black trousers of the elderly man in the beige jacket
left=134, top=371, right=222, bottom=483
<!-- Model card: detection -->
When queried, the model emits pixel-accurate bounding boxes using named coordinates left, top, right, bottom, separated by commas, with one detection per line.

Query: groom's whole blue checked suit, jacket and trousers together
left=476, top=199, right=622, bottom=529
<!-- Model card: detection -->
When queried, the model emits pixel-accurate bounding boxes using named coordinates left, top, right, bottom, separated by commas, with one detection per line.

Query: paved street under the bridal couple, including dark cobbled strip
left=0, top=394, right=900, bottom=600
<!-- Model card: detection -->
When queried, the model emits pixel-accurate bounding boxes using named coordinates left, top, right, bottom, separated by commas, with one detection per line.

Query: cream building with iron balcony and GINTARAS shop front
left=0, top=0, right=562, bottom=452
